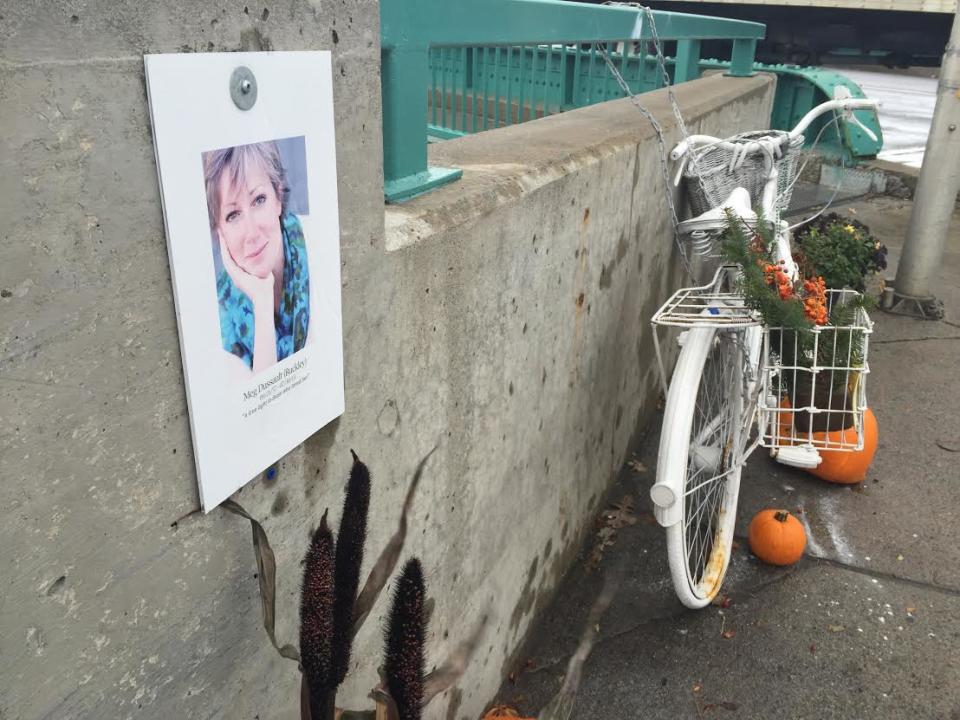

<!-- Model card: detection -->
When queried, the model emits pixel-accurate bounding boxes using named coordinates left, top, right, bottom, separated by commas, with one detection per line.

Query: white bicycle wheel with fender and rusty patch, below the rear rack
left=657, top=328, right=747, bottom=608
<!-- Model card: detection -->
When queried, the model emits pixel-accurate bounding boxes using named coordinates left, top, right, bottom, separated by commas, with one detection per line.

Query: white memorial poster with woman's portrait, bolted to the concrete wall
left=144, top=52, right=344, bottom=512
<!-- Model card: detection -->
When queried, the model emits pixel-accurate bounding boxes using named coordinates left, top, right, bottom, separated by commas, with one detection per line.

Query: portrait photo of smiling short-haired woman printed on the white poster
left=203, top=137, right=311, bottom=374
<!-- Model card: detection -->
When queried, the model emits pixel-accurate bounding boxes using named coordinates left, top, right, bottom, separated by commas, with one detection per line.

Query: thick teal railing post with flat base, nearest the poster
left=380, top=47, right=463, bottom=202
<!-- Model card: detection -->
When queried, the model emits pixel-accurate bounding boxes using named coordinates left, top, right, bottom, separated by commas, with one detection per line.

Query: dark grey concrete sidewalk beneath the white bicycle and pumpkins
left=498, top=198, right=960, bottom=720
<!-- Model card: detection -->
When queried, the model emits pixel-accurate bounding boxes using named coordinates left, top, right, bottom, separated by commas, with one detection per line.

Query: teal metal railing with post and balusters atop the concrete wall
left=380, top=0, right=764, bottom=202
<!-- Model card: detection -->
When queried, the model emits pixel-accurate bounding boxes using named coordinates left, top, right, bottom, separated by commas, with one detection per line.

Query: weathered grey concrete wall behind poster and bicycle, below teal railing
left=0, top=0, right=772, bottom=720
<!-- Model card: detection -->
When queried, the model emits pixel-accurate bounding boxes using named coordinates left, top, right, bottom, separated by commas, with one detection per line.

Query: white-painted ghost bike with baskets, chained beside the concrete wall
left=650, top=88, right=877, bottom=608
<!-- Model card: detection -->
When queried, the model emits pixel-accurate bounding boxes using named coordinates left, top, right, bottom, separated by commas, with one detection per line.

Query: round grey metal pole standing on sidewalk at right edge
left=893, top=8, right=960, bottom=319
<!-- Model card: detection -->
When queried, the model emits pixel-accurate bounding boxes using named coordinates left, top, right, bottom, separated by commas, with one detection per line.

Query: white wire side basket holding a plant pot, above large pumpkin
left=758, top=290, right=873, bottom=451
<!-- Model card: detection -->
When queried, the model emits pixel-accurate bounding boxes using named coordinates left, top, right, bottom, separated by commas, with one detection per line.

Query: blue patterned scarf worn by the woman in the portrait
left=217, top=213, right=310, bottom=370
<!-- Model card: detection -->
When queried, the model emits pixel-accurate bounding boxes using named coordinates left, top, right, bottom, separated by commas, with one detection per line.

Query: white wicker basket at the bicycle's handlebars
left=683, top=130, right=803, bottom=219
